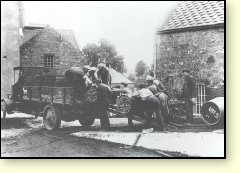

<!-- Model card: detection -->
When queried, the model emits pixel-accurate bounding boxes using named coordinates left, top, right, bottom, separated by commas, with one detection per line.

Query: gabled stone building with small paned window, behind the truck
left=20, top=24, right=84, bottom=75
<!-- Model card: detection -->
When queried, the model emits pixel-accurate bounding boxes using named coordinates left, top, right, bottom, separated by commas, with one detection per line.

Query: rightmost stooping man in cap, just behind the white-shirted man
left=146, top=75, right=169, bottom=123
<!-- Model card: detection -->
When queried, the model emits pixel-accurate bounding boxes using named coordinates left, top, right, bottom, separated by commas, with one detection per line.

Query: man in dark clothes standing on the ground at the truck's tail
left=96, top=79, right=111, bottom=130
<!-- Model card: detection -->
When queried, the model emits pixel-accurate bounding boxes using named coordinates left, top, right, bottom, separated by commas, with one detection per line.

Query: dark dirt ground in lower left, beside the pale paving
left=1, top=114, right=183, bottom=157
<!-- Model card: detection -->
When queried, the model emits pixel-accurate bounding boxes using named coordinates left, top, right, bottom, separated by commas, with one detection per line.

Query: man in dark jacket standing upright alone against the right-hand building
left=182, top=68, right=196, bottom=124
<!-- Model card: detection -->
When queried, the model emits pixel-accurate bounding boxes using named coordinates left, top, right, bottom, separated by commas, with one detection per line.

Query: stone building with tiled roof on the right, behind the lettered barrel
left=155, top=1, right=225, bottom=112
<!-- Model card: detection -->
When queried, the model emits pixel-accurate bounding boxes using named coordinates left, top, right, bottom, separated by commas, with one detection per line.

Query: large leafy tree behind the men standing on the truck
left=82, top=39, right=127, bottom=73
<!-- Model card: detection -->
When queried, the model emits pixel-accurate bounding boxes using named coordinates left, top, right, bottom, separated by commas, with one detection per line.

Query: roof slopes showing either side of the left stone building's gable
left=20, top=26, right=79, bottom=50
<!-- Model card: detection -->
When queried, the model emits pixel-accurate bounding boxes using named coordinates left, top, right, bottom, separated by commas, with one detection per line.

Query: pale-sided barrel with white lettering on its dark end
left=201, top=97, right=224, bottom=126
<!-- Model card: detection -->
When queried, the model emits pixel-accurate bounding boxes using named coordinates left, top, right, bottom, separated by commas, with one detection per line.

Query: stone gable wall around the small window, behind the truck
left=20, top=28, right=83, bottom=74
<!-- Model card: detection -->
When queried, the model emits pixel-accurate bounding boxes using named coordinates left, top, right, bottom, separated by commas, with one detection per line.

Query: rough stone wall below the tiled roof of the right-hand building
left=156, top=28, right=224, bottom=99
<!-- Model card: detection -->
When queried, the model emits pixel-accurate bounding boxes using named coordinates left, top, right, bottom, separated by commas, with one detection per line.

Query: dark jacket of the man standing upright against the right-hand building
left=183, top=75, right=197, bottom=100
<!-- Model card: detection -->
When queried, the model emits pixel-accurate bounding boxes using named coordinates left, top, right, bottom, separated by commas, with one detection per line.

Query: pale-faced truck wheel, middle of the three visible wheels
left=43, top=105, right=61, bottom=131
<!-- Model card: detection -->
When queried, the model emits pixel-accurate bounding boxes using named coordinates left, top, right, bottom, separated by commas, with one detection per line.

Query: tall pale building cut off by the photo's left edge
left=1, top=1, right=24, bottom=97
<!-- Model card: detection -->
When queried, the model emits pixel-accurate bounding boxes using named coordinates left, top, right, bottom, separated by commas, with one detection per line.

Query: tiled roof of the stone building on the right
left=159, top=1, right=224, bottom=32
